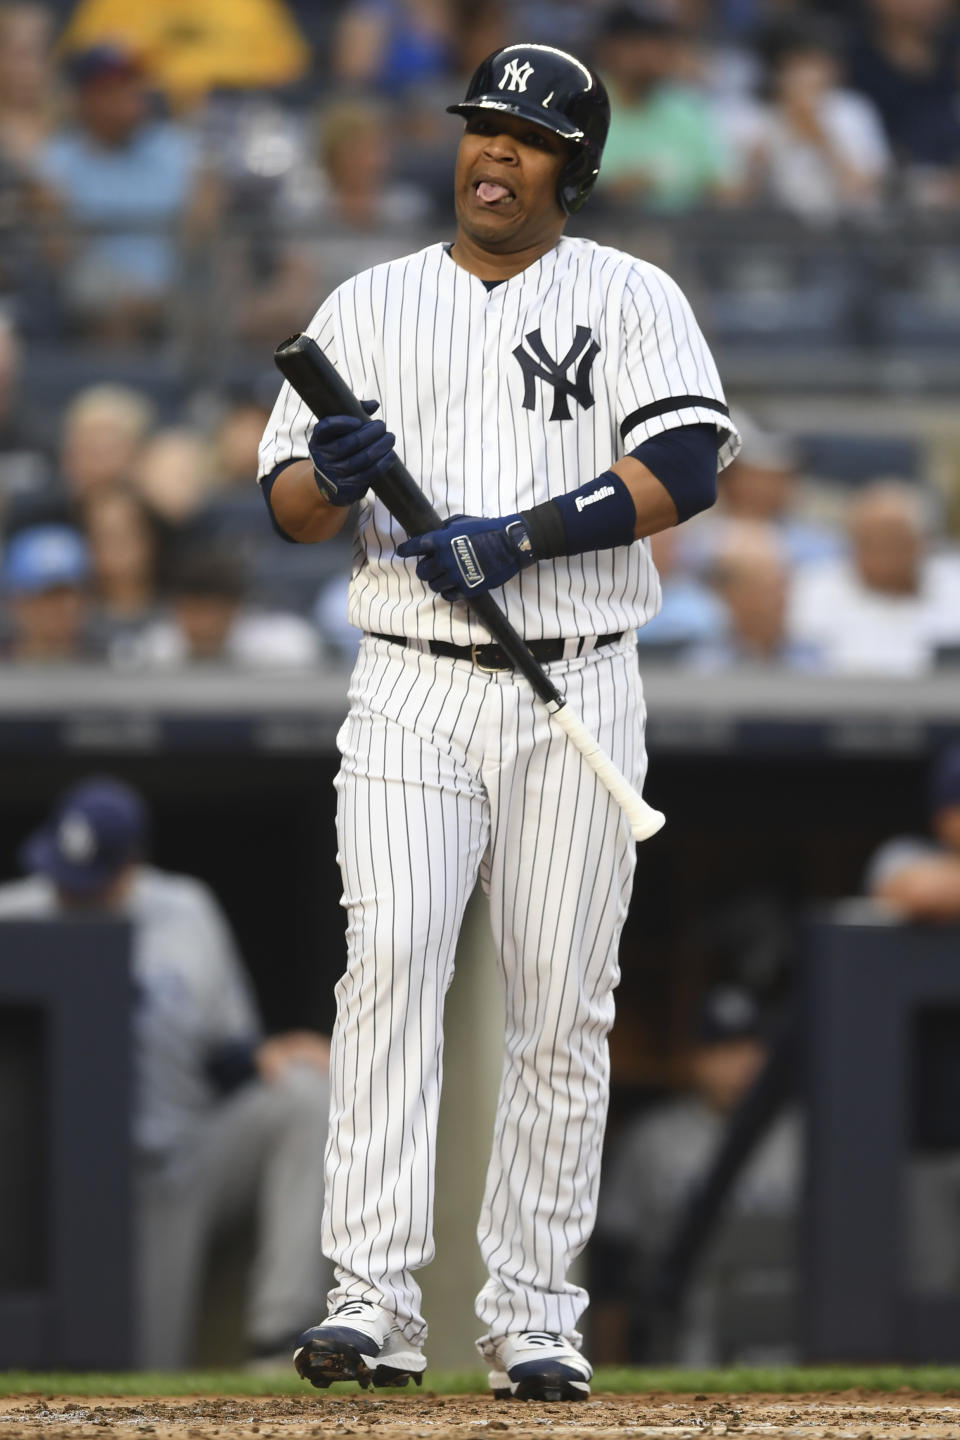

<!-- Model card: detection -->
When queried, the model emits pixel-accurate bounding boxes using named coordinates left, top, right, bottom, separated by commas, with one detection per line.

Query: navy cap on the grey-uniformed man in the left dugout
left=20, top=778, right=148, bottom=896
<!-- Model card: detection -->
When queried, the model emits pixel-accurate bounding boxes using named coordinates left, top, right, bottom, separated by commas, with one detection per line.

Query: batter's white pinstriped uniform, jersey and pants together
left=261, top=239, right=738, bottom=1345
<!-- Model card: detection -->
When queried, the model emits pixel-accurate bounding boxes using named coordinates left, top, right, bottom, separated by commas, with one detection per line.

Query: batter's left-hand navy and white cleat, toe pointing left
left=294, top=1300, right=426, bottom=1390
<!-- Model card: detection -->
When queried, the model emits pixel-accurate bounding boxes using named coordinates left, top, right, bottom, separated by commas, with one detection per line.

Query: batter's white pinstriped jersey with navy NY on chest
left=259, top=238, right=740, bottom=644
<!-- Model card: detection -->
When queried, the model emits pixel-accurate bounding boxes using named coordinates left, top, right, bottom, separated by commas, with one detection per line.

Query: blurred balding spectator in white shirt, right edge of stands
left=789, top=481, right=960, bottom=675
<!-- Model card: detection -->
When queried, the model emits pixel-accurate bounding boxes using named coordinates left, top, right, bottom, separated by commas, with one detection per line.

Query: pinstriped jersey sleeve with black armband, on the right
left=616, top=265, right=740, bottom=469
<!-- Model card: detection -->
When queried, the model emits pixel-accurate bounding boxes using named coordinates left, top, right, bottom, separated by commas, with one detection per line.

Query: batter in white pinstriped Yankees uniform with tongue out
left=261, top=45, right=738, bottom=1400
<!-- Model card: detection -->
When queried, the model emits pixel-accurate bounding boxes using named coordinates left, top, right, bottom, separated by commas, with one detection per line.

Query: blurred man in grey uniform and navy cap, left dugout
left=0, top=779, right=328, bottom=1369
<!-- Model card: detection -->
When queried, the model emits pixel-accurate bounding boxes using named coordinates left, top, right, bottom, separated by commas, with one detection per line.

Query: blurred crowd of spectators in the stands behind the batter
left=0, top=0, right=960, bottom=675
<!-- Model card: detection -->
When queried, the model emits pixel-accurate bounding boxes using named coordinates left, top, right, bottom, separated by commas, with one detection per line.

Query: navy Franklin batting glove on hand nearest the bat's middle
left=397, top=516, right=537, bottom=600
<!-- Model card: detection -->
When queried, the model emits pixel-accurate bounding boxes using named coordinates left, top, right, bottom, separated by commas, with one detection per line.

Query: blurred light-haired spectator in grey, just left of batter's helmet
left=237, top=99, right=430, bottom=341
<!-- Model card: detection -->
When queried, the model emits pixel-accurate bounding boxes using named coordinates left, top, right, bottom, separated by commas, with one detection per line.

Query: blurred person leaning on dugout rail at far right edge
left=865, top=744, right=960, bottom=924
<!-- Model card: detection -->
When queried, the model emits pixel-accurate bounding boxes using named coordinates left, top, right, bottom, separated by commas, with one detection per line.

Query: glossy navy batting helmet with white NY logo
left=446, top=45, right=610, bottom=215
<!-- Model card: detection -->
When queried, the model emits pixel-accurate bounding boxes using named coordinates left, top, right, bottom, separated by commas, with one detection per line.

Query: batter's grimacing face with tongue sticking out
left=455, top=111, right=569, bottom=253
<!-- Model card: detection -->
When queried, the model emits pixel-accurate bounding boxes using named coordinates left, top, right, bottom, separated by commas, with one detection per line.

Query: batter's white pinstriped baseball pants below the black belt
left=324, top=634, right=646, bottom=1345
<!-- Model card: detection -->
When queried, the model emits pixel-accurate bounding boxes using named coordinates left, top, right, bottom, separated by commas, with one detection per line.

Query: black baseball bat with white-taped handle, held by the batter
left=273, top=336, right=665, bottom=840
